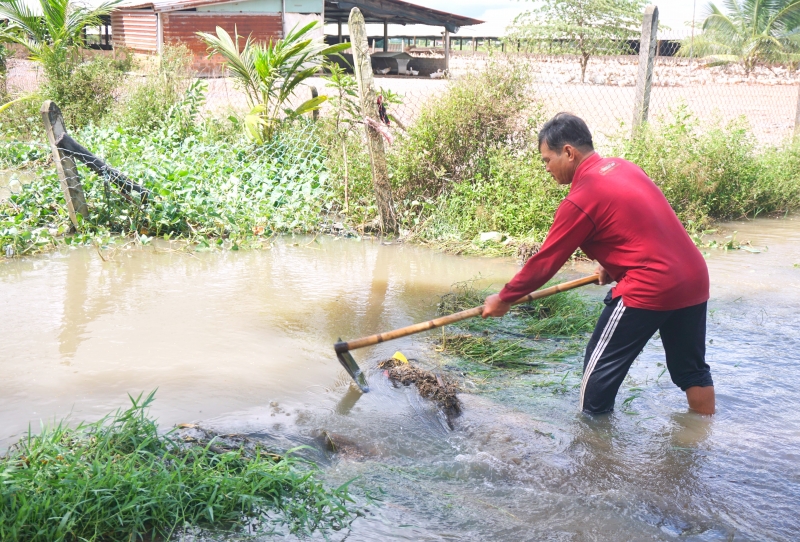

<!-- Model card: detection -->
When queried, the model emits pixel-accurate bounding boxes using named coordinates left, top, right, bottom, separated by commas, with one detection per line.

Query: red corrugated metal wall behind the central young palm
left=161, top=11, right=283, bottom=74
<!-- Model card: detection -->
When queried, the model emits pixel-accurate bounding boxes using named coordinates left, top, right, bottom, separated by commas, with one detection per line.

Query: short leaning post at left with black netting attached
left=40, top=100, right=89, bottom=229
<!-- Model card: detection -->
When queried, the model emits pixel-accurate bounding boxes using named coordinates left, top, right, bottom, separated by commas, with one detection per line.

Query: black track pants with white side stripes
left=580, top=291, right=714, bottom=414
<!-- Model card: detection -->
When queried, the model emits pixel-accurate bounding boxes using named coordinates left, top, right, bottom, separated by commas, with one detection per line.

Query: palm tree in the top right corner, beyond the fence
left=679, top=0, right=800, bottom=74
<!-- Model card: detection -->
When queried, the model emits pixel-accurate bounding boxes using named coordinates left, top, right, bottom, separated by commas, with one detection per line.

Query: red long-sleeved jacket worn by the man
left=500, top=154, right=709, bottom=311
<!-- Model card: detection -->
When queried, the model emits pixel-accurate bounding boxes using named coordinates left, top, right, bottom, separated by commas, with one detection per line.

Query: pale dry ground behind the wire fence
left=8, top=55, right=800, bottom=148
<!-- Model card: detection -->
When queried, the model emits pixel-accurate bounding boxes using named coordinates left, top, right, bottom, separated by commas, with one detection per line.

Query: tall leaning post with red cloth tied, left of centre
left=347, top=8, right=397, bottom=233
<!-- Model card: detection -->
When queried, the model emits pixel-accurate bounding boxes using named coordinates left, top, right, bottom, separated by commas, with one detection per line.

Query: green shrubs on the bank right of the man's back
left=619, top=108, right=800, bottom=229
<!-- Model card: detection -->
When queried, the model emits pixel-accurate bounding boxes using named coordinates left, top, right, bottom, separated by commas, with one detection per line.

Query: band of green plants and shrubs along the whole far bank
left=0, top=51, right=800, bottom=256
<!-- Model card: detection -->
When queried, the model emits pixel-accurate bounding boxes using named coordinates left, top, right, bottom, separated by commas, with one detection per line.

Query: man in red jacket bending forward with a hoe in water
left=483, top=113, right=715, bottom=414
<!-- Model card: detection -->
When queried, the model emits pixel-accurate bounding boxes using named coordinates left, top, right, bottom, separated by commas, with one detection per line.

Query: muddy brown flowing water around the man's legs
left=0, top=218, right=800, bottom=541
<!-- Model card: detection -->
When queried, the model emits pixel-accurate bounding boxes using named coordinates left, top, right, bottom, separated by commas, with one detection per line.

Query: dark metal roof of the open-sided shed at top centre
left=325, top=0, right=483, bottom=33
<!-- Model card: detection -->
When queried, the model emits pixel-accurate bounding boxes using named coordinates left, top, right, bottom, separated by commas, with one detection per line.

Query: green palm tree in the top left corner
left=0, top=0, right=121, bottom=77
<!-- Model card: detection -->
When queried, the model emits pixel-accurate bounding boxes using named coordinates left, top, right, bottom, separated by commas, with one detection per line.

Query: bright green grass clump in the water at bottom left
left=0, top=393, right=355, bottom=542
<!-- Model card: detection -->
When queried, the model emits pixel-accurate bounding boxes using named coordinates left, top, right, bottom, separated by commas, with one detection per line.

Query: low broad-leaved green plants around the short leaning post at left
left=0, top=87, right=332, bottom=256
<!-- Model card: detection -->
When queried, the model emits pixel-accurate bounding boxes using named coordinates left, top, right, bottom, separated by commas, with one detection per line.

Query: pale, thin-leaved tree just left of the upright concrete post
left=506, top=0, right=645, bottom=82
